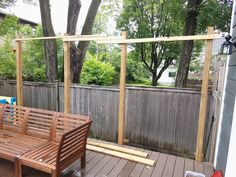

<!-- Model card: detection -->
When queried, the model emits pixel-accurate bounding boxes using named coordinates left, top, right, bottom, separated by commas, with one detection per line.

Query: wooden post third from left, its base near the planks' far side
left=118, top=31, right=128, bottom=145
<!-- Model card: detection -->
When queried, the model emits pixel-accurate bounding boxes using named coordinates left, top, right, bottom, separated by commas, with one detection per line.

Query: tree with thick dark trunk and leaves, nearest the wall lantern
left=176, top=0, right=232, bottom=87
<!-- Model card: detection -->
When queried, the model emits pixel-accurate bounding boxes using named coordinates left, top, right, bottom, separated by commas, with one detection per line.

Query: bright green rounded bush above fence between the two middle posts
left=81, top=59, right=115, bottom=85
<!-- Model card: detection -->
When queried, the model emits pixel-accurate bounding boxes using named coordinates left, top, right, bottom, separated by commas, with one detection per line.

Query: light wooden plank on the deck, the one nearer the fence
left=87, top=140, right=148, bottom=157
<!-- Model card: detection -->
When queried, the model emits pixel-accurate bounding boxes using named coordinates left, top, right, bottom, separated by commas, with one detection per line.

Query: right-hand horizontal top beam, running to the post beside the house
left=96, top=34, right=222, bottom=44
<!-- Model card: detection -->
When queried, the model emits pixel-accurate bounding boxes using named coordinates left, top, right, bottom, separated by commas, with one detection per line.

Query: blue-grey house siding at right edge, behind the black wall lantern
left=215, top=1, right=236, bottom=172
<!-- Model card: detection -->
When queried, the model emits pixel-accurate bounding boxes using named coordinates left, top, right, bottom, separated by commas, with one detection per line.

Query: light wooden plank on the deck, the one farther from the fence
left=86, top=145, right=155, bottom=166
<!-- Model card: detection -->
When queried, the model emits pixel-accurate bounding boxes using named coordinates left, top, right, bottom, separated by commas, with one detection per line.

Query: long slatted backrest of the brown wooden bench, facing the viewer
left=0, top=104, right=89, bottom=142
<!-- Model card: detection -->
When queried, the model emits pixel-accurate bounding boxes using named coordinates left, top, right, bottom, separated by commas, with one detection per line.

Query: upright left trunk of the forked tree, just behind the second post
left=66, top=0, right=81, bottom=82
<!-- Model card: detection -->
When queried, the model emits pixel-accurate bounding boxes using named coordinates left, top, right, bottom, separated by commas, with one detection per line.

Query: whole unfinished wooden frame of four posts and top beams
left=16, top=27, right=222, bottom=161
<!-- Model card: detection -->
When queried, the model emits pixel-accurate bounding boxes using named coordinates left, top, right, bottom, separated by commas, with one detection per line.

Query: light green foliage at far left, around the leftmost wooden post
left=0, top=16, right=46, bottom=81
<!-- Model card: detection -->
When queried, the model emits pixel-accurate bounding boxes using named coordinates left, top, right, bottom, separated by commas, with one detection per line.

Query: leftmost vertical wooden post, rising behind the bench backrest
left=16, top=35, right=23, bottom=106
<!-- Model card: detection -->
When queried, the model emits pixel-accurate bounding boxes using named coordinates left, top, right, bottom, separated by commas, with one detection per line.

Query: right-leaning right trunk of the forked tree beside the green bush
left=72, top=0, right=101, bottom=83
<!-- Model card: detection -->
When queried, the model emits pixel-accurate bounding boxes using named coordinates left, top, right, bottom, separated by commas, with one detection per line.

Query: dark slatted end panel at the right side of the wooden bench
left=56, top=118, right=92, bottom=171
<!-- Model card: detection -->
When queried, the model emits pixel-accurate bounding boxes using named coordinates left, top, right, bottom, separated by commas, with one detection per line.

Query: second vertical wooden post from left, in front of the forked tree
left=64, top=37, right=70, bottom=113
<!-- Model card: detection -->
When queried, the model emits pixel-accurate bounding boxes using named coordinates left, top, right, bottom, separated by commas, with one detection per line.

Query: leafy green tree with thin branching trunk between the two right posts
left=117, top=0, right=183, bottom=86
